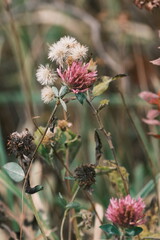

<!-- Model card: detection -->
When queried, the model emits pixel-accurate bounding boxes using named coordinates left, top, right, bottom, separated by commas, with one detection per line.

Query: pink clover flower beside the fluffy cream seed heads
left=57, top=62, right=97, bottom=93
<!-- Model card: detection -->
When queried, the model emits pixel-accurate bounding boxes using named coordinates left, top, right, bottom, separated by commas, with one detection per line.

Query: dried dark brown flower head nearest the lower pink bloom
left=74, top=164, right=96, bottom=190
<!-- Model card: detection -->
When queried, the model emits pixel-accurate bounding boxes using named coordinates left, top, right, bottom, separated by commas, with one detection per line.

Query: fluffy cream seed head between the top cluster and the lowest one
left=36, top=65, right=57, bottom=85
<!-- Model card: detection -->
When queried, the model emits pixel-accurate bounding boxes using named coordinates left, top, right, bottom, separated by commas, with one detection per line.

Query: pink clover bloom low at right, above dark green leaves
left=105, top=195, right=145, bottom=228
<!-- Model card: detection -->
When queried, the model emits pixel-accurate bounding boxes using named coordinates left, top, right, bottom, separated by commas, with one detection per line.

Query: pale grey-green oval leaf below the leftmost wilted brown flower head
left=3, top=162, right=25, bottom=182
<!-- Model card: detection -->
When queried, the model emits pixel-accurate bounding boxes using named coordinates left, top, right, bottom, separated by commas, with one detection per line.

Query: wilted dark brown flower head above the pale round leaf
left=7, top=128, right=35, bottom=158
